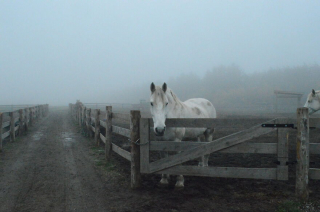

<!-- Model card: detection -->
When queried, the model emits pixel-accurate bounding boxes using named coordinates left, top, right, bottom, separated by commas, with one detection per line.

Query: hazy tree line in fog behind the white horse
left=168, top=65, right=320, bottom=112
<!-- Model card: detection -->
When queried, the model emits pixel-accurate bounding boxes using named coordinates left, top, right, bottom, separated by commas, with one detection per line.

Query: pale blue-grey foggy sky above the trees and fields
left=0, top=0, right=320, bottom=105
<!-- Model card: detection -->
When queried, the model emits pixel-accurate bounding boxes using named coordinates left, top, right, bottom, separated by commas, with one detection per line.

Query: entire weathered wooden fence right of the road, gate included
left=70, top=103, right=320, bottom=200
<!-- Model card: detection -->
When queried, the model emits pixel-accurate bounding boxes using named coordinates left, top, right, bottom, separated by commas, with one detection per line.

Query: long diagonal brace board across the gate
left=149, top=120, right=275, bottom=173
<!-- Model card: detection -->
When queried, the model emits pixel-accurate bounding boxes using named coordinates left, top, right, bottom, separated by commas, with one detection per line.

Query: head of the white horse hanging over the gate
left=150, top=83, right=169, bottom=136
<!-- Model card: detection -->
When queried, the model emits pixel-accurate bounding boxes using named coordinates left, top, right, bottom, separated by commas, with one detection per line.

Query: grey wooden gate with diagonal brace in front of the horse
left=140, top=118, right=289, bottom=180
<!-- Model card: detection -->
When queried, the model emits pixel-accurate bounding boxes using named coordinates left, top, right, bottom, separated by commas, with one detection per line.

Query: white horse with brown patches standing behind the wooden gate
left=150, top=83, right=217, bottom=187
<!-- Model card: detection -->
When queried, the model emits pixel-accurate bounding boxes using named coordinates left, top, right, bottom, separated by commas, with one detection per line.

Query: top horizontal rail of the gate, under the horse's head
left=149, top=118, right=273, bottom=128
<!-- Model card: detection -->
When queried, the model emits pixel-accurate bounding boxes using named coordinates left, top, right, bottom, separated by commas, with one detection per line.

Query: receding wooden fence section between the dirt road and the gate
left=69, top=102, right=141, bottom=188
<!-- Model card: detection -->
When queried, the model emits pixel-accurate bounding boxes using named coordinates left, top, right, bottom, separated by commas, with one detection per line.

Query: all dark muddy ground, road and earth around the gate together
left=0, top=110, right=320, bottom=212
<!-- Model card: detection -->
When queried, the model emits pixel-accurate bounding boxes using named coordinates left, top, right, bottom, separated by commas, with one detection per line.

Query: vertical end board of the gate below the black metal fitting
left=277, top=126, right=289, bottom=180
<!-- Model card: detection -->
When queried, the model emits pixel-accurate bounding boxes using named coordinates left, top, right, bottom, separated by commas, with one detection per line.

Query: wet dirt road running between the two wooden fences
left=0, top=111, right=126, bottom=211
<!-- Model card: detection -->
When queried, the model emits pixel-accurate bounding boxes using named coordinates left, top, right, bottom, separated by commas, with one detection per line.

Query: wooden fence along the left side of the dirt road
left=0, top=104, right=49, bottom=151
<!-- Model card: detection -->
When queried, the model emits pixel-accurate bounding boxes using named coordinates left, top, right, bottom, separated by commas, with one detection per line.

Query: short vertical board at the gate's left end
left=140, top=119, right=150, bottom=173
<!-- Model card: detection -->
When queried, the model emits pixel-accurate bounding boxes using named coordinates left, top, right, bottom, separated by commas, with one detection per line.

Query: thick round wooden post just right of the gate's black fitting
left=296, top=107, right=309, bottom=201
